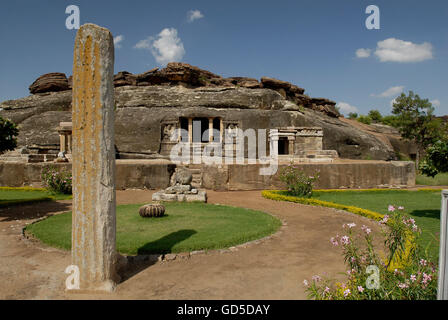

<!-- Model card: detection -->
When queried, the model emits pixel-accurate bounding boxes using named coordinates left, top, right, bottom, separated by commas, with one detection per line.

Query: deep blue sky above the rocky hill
left=0, top=0, right=448, bottom=115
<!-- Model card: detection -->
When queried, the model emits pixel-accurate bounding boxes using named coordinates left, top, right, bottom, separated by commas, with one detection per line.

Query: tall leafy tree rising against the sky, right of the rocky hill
left=392, top=91, right=442, bottom=163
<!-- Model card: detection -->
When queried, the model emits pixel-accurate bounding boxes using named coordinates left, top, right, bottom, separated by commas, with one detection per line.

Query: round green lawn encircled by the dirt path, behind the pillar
left=26, top=203, right=281, bottom=255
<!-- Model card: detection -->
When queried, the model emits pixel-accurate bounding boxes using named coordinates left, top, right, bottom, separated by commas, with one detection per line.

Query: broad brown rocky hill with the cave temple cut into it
left=0, top=63, right=412, bottom=160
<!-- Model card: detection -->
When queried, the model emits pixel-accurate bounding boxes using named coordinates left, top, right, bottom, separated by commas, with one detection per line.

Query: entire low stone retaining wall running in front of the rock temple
left=0, top=160, right=415, bottom=191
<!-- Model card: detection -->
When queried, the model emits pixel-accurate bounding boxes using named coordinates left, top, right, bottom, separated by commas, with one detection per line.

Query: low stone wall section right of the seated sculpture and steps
left=202, top=161, right=415, bottom=191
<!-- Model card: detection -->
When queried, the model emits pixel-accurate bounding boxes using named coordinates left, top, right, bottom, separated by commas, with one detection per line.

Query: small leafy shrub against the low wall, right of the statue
left=279, top=164, right=319, bottom=197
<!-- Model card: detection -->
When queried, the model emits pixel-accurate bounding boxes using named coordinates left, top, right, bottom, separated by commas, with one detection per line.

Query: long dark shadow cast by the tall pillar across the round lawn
left=120, top=229, right=197, bottom=283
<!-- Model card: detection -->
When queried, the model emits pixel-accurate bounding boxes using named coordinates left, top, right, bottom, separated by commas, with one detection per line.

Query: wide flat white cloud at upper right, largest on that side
left=375, top=38, right=432, bottom=62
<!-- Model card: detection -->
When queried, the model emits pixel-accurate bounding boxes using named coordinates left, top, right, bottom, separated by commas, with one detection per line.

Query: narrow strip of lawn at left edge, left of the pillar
left=0, top=188, right=71, bottom=207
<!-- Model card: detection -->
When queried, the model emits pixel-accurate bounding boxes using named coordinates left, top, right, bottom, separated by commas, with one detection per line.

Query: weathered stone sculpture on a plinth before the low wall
left=152, top=168, right=207, bottom=202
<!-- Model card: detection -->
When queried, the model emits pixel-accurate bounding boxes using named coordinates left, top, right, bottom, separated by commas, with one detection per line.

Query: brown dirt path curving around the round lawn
left=0, top=190, right=378, bottom=299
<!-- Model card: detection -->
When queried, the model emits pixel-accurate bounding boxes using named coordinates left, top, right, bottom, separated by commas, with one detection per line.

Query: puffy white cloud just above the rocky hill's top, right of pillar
left=134, top=28, right=185, bottom=65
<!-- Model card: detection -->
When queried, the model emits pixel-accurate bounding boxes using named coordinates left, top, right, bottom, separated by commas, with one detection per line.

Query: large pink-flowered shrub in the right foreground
left=303, top=205, right=437, bottom=300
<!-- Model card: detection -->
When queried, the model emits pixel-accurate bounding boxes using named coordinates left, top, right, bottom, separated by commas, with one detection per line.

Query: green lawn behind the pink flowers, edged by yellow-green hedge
left=312, top=190, right=441, bottom=259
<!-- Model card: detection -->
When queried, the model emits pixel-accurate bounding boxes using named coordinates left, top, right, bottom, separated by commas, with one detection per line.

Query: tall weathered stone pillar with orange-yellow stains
left=72, top=24, right=118, bottom=291
